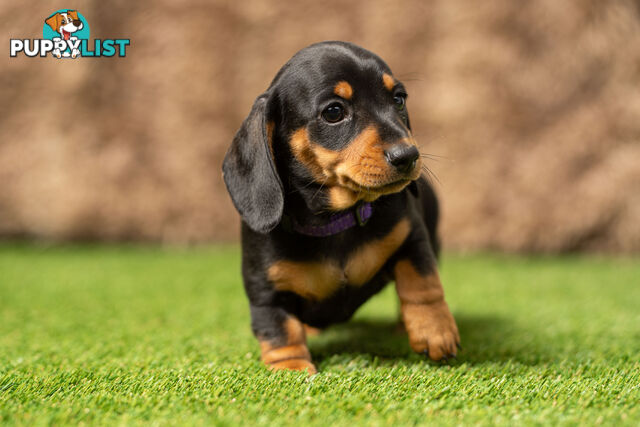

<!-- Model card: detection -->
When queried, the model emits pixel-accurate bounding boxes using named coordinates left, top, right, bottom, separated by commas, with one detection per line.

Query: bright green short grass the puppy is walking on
left=0, top=244, right=640, bottom=425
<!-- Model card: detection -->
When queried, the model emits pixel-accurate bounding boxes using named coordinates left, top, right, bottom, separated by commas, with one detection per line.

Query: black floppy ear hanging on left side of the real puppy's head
left=222, top=93, right=284, bottom=233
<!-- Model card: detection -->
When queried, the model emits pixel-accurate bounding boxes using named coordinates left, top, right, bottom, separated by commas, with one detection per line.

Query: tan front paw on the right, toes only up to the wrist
left=402, top=300, right=460, bottom=360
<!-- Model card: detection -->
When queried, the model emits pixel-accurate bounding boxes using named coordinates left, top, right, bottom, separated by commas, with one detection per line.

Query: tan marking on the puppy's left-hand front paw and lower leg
left=260, top=316, right=317, bottom=375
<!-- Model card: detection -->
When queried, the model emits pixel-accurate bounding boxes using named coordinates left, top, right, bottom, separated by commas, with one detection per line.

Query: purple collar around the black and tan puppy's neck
left=282, top=202, right=373, bottom=237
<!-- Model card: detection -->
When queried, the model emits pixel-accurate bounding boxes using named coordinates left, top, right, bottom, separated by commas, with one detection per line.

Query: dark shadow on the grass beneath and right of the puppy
left=309, top=313, right=553, bottom=365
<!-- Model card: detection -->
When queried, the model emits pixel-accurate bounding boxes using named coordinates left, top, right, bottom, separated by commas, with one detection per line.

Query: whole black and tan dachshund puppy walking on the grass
left=223, top=42, right=459, bottom=373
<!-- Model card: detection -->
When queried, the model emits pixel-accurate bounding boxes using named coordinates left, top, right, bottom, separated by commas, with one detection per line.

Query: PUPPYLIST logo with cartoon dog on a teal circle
left=10, top=9, right=131, bottom=59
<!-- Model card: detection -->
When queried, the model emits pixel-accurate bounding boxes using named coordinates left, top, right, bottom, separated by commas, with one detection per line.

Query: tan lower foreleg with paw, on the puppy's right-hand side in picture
left=394, top=260, right=460, bottom=360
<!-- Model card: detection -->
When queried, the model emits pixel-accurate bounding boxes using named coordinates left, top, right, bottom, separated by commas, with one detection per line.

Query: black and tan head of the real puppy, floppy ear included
left=223, top=42, right=420, bottom=232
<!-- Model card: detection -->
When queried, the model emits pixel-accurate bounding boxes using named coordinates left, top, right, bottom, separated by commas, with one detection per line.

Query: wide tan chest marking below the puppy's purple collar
left=267, top=220, right=409, bottom=301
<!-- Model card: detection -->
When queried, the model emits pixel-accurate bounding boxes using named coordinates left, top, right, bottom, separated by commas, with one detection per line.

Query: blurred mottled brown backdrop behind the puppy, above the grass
left=0, top=0, right=640, bottom=252
